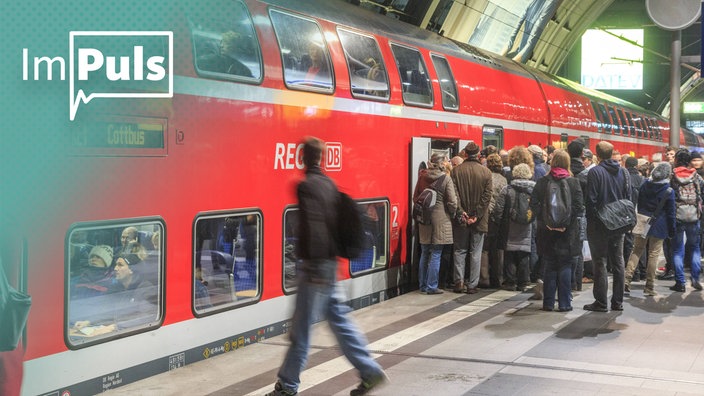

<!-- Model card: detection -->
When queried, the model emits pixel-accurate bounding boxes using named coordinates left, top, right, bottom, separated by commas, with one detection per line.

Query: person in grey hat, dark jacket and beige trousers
left=624, top=162, right=676, bottom=296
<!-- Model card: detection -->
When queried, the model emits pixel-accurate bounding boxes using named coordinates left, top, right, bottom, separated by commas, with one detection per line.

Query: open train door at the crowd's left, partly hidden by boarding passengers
left=404, top=137, right=460, bottom=289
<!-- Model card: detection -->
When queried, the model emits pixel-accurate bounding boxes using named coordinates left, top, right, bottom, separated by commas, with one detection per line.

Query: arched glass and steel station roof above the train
left=345, top=0, right=704, bottom=122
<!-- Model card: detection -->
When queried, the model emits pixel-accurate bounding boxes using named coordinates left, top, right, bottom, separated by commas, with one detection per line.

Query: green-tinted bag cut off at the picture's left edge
left=0, top=263, right=32, bottom=351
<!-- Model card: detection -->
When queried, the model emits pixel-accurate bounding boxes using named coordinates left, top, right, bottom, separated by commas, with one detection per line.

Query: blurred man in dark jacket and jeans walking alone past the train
left=267, top=137, right=387, bottom=396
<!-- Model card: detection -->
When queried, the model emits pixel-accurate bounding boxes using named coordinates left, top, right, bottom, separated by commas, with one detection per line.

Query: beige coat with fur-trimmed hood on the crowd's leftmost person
left=413, top=168, right=457, bottom=245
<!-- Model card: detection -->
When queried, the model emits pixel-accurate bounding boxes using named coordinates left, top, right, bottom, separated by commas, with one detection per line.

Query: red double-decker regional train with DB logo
left=0, top=0, right=698, bottom=395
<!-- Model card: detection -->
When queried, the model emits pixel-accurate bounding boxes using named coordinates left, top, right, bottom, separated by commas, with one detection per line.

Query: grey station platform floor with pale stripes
left=106, top=281, right=704, bottom=396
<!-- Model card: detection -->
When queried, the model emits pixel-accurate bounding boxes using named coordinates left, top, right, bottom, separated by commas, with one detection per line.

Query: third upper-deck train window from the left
left=337, top=28, right=389, bottom=100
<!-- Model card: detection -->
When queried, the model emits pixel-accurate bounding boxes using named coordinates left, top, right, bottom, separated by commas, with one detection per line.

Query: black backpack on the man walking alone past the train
left=336, top=192, right=369, bottom=259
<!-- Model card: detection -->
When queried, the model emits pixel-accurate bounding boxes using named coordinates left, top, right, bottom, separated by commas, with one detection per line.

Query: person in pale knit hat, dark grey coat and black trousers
left=493, top=164, right=535, bottom=291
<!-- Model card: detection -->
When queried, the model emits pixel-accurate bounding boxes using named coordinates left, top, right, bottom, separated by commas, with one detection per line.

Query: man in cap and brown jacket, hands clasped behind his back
left=451, top=142, right=492, bottom=294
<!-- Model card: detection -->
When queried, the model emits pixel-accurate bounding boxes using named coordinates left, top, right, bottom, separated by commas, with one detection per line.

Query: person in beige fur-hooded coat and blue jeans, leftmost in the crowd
left=413, top=153, right=457, bottom=294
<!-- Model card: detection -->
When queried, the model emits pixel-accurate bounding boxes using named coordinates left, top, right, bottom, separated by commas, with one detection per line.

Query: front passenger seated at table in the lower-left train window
left=69, top=254, right=158, bottom=337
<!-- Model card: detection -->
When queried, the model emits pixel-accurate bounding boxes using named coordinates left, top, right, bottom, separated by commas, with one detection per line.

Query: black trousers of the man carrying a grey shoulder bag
left=589, top=232, right=625, bottom=308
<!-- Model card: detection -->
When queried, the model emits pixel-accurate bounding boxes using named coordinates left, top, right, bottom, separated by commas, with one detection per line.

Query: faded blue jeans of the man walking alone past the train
left=278, top=259, right=382, bottom=391
